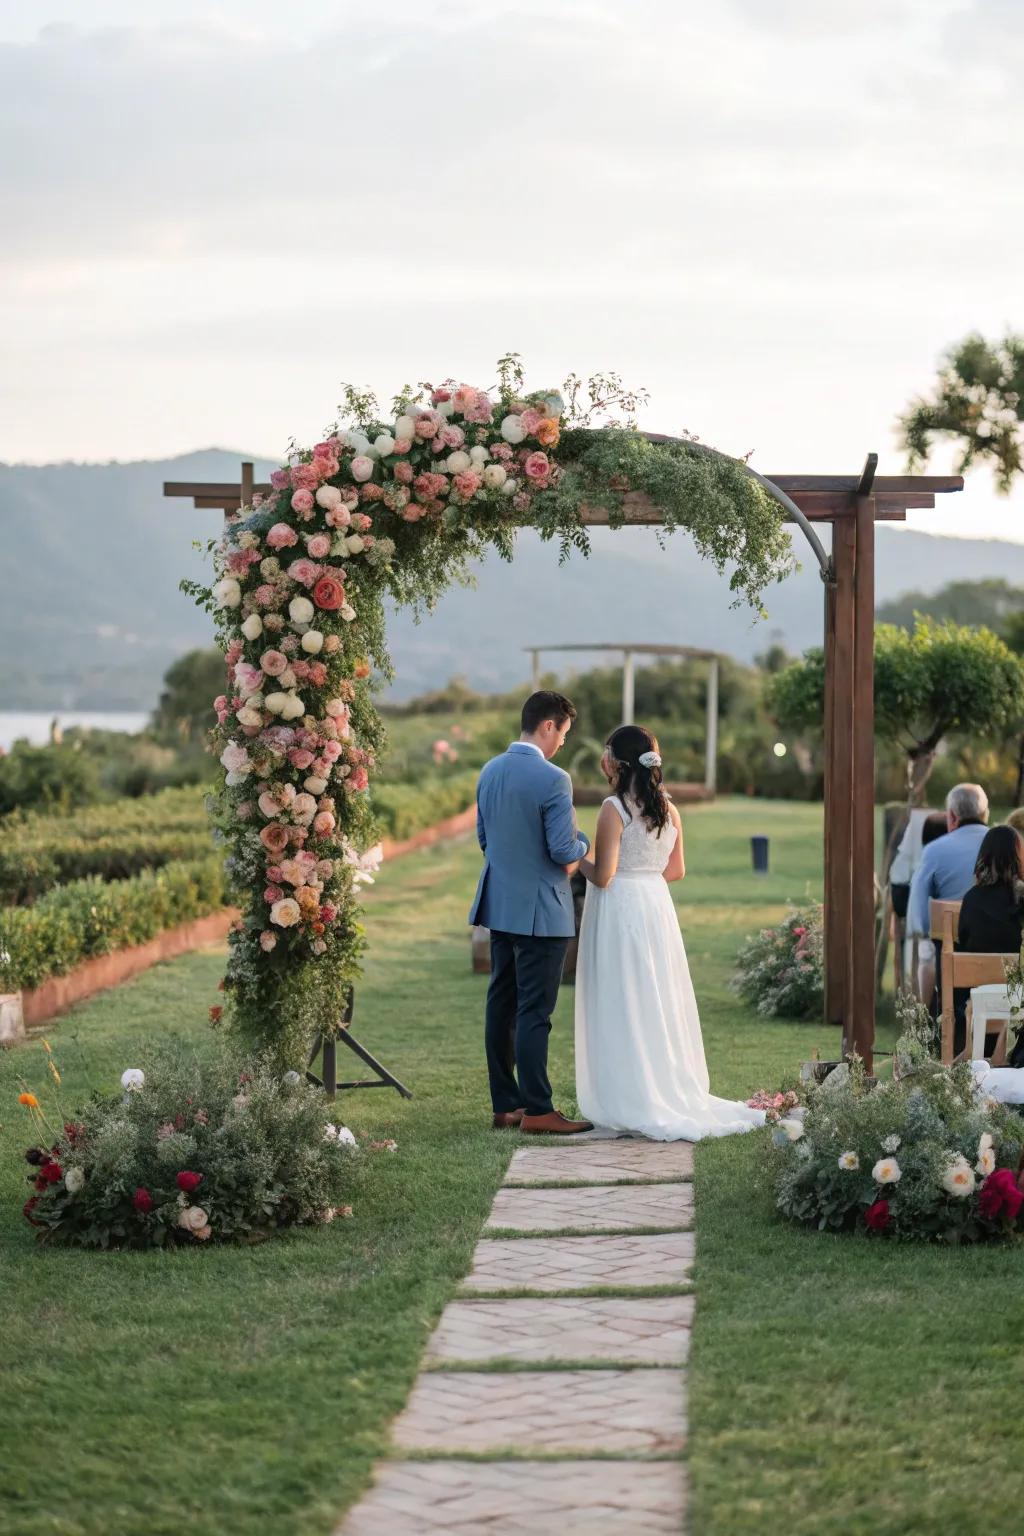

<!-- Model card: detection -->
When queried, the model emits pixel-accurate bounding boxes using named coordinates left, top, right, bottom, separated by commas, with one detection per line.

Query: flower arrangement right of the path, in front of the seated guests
left=769, top=1003, right=1024, bottom=1243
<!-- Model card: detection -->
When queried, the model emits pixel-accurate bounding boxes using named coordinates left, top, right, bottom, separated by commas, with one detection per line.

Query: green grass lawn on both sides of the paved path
left=0, top=800, right=1024, bottom=1536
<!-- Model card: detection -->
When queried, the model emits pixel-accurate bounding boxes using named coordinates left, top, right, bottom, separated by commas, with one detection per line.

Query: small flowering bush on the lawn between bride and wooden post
left=732, top=902, right=824, bottom=1018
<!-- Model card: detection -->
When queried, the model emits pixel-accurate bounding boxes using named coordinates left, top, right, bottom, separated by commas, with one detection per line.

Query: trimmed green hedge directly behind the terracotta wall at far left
left=0, top=854, right=229, bottom=991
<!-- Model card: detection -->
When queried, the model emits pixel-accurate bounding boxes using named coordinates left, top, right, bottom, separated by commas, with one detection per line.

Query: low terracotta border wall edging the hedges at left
left=21, top=805, right=476, bottom=1028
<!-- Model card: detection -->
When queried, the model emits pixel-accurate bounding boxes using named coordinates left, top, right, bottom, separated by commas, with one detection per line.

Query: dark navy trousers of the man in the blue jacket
left=484, top=931, right=570, bottom=1115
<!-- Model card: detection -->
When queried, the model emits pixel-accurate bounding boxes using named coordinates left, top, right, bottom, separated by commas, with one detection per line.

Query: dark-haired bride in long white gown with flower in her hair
left=576, top=725, right=765, bottom=1141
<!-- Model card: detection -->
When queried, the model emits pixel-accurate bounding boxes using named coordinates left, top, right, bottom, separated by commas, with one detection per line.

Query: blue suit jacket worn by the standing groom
left=470, top=742, right=590, bottom=938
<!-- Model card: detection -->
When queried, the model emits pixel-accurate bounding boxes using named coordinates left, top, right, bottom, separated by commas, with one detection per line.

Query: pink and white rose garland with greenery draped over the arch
left=183, top=356, right=791, bottom=1064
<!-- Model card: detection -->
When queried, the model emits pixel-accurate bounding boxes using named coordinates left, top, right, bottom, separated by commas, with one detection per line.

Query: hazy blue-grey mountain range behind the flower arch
left=0, top=449, right=1024, bottom=710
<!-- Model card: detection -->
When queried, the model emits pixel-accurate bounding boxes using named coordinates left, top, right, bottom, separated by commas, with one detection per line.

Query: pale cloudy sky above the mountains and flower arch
left=0, top=0, right=1024, bottom=542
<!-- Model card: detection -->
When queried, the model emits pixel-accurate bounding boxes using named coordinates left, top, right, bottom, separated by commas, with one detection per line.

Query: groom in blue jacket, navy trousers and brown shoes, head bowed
left=470, top=693, right=593, bottom=1137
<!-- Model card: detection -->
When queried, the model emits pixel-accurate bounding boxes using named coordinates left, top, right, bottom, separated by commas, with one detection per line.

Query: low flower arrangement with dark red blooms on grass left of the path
left=20, top=1052, right=356, bottom=1249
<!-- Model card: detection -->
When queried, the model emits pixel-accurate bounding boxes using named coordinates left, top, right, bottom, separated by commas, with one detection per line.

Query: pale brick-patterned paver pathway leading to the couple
left=336, top=1138, right=694, bottom=1536
